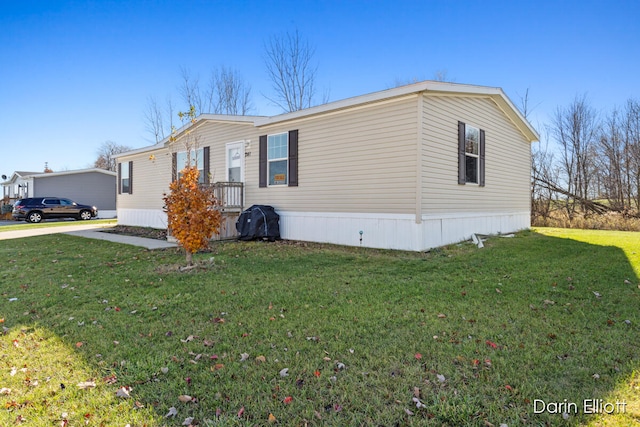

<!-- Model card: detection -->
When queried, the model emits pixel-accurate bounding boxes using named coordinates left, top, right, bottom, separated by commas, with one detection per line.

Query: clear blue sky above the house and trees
left=0, top=0, right=640, bottom=176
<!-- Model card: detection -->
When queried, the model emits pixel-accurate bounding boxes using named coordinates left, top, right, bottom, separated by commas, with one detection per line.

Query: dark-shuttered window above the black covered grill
left=259, top=130, right=298, bottom=187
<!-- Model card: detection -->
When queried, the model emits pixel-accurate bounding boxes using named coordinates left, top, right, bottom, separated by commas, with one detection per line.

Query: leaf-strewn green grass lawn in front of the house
left=0, top=229, right=640, bottom=427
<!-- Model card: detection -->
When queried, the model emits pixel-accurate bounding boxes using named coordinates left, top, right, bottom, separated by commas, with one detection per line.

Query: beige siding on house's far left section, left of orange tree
left=116, top=148, right=171, bottom=209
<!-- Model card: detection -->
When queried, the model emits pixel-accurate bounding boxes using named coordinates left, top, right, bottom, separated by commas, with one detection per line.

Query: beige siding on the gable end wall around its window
left=422, top=95, right=531, bottom=214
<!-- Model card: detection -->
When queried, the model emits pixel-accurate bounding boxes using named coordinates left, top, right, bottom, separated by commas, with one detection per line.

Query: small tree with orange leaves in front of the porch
left=163, top=107, right=222, bottom=265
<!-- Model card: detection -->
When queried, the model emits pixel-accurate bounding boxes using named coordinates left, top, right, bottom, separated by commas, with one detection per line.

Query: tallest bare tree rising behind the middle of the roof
left=265, top=30, right=318, bottom=112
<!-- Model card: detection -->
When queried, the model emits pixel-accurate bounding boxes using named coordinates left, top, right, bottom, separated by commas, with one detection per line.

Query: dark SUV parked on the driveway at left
left=11, top=197, right=98, bottom=222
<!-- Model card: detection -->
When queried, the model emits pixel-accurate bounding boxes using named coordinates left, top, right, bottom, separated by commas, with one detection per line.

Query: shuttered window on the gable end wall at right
left=458, top=122, right=485, bottom=187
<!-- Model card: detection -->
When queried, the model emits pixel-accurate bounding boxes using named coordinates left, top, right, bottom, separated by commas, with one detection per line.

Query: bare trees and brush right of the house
left=532, top=95, right=640, bottom=222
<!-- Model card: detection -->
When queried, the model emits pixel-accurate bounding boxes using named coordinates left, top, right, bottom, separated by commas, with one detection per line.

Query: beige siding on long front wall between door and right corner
left=246, top=96, right=417, bottom=214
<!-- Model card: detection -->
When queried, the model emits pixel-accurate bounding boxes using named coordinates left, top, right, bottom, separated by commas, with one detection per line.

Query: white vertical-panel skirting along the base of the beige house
left=118, top=208, right=530, bottom=251
